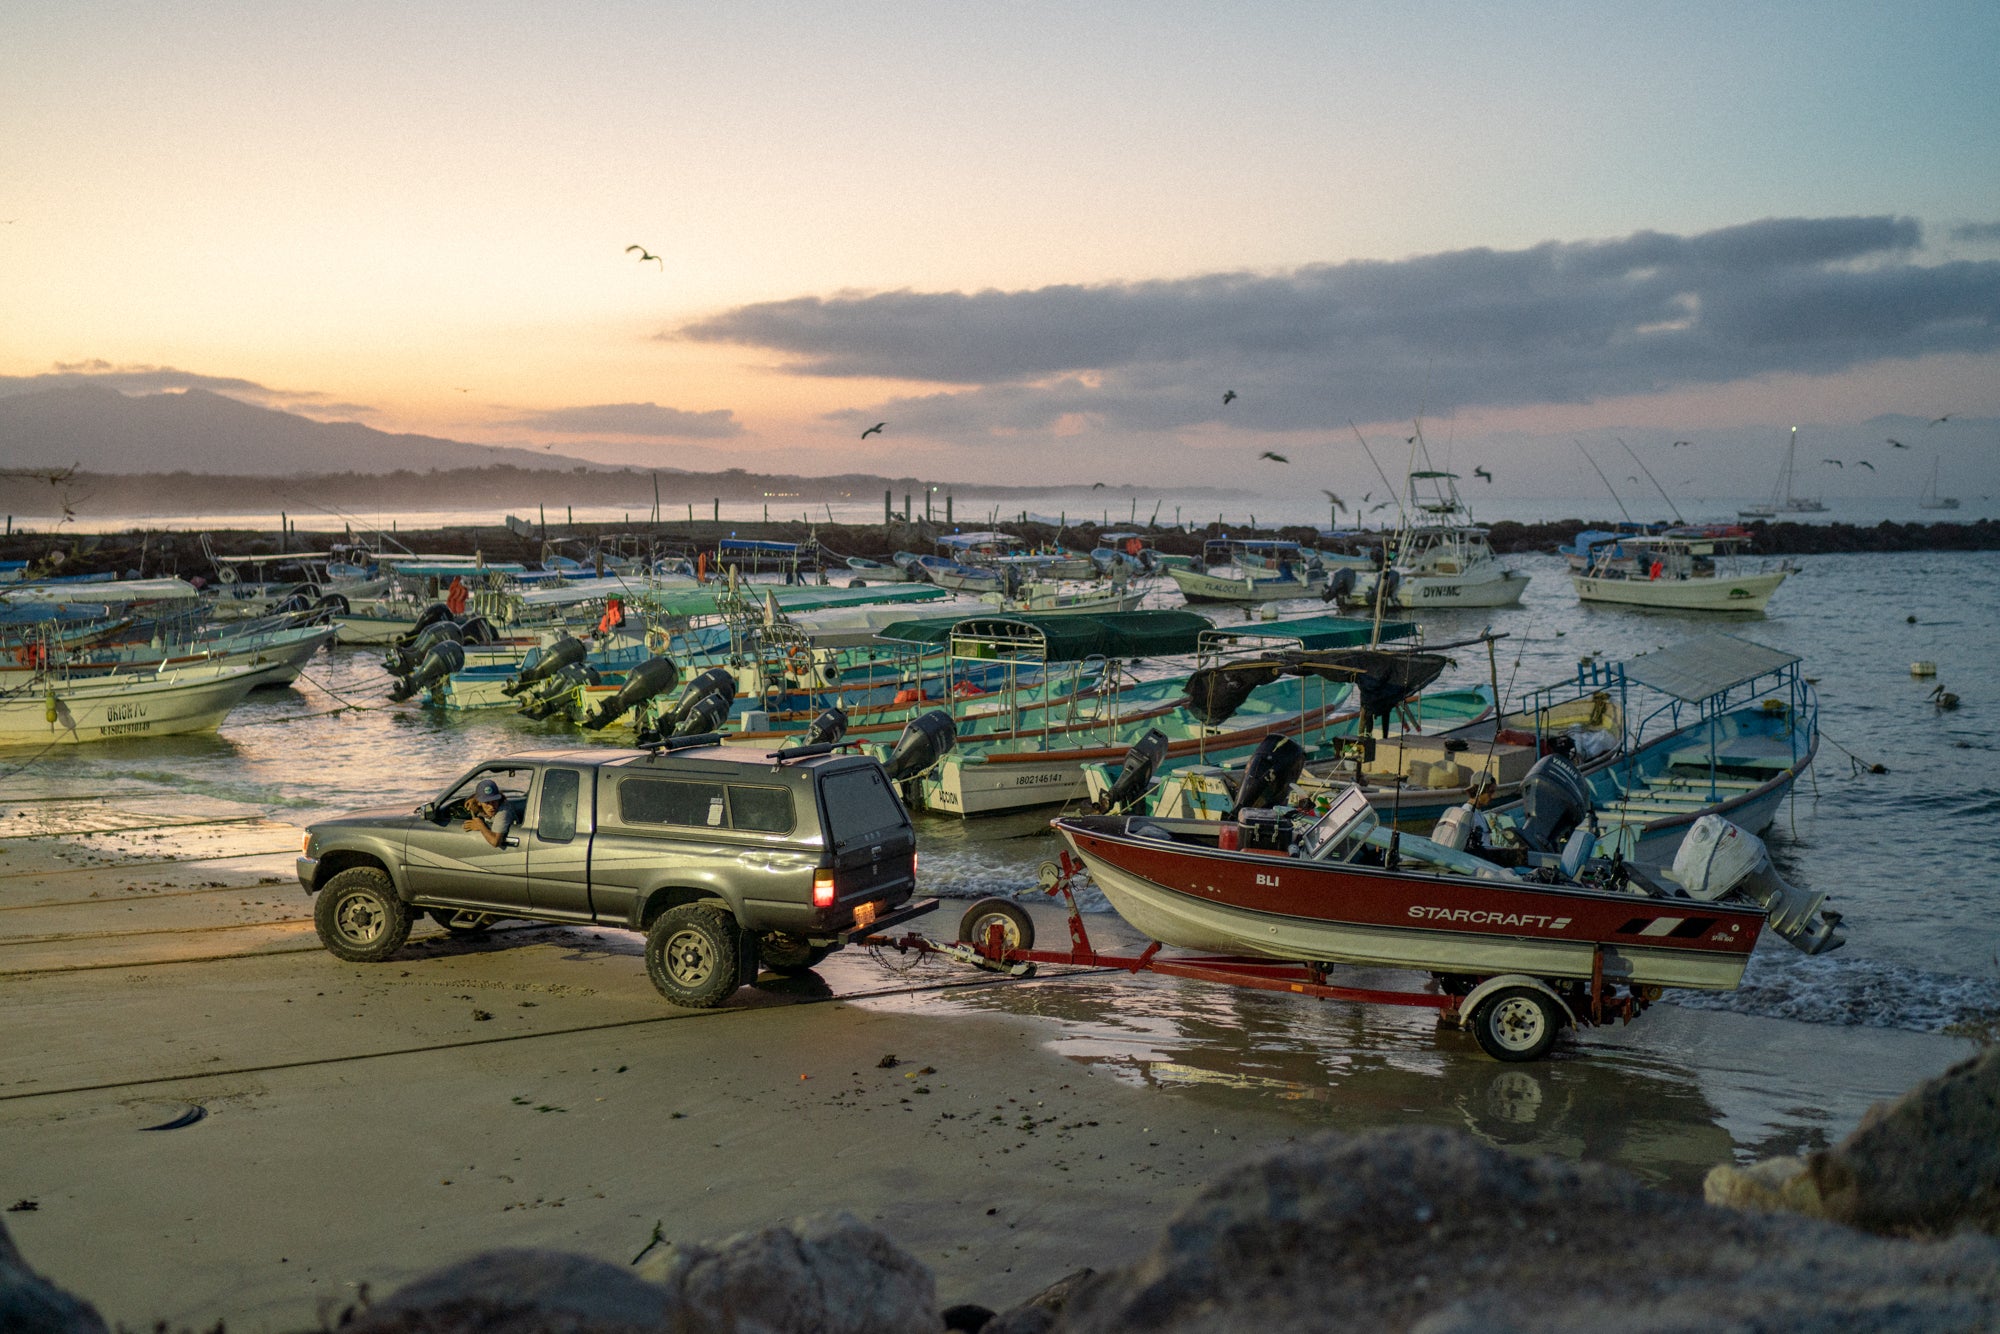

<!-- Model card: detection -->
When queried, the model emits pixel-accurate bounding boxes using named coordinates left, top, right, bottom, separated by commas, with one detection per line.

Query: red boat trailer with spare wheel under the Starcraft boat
left=856, top=850, right=1660, bottom=1062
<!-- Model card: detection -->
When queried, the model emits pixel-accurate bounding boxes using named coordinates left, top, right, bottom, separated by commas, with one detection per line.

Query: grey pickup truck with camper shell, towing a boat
left=298, top=734, right=936, bottom=1008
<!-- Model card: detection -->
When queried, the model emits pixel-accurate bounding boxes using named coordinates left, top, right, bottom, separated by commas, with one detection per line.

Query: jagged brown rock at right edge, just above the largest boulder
left=1706, top=1048, right=2000, bottom=1236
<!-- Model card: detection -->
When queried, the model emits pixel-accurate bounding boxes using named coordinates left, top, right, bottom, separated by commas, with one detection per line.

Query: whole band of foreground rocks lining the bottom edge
left=15, top=1048, right=2000, bottom=1334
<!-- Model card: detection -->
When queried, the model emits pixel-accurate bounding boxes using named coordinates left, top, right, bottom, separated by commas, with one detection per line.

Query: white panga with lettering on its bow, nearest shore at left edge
left=0, top=664, right=266, bottom=746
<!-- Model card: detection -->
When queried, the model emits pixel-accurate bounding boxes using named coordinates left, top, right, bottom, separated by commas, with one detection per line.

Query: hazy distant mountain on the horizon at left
left=0, top=384, right=604, bottom=476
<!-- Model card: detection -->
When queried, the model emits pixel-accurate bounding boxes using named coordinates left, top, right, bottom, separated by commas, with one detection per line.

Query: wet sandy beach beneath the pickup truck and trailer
left=0, top=802, right=1972, bottom=1330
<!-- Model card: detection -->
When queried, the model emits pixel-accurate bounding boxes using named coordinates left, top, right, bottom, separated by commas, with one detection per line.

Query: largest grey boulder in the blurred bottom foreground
left=1056, top=1130, right=2000, bottom=1334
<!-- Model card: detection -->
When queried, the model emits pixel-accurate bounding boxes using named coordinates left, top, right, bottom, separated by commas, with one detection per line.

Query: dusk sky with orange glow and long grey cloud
left=0, top=0, right=2000, bottom=494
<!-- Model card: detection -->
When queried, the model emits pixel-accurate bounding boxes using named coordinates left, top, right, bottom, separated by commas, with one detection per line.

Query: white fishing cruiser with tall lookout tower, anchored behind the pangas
left=1326, top=470, right=1528, bottom=612
